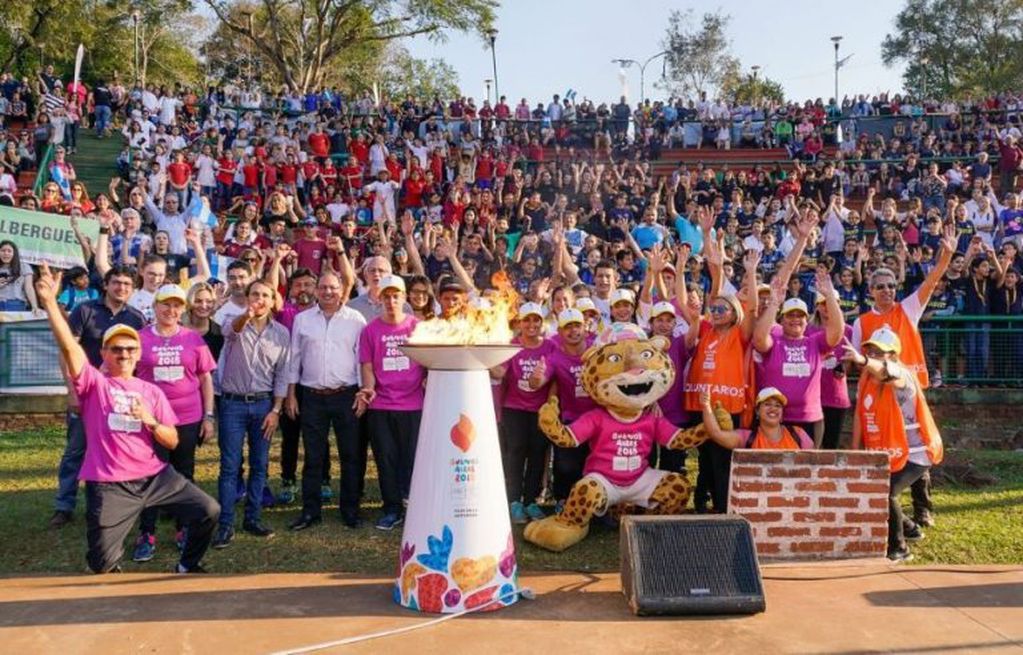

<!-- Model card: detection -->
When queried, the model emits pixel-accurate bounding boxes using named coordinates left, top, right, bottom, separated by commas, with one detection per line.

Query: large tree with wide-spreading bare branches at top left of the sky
left=205, top=0, right=497, bottom=92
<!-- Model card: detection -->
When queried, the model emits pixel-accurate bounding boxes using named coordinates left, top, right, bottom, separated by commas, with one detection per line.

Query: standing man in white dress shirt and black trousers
left=284, top=271, right=366, bottom=530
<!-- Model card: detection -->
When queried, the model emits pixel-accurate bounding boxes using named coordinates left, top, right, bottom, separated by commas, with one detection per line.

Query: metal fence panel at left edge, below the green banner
left=0, top=320, right=64, bottom=388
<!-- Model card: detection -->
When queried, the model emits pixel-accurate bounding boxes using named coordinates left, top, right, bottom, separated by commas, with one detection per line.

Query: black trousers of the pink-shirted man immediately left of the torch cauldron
left=366, top=409, right=422, bottom=515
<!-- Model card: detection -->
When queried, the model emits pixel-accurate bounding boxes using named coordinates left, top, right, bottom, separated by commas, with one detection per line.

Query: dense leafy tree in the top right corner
left=881, top=0, right=1023, bottom=97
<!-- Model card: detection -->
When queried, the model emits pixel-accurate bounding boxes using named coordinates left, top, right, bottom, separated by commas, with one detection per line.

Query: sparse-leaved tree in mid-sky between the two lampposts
left=661, top=9, right=739, bottom=96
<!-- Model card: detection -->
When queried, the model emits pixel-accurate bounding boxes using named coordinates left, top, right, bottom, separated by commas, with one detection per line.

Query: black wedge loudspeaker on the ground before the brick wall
left=621, top=515, right=766, bottom=615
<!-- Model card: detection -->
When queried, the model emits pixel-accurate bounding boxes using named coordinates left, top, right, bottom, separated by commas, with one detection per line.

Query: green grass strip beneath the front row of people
left=0, top=429, right=1023, bottom=575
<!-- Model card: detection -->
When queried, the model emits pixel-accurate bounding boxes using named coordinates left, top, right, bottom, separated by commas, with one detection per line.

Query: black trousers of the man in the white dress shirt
left=299, top=387, right=361, bottom=519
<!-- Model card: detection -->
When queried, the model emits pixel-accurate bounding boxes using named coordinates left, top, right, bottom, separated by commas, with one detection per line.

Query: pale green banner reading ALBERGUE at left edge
left=0, top=207, right=99, bottom=268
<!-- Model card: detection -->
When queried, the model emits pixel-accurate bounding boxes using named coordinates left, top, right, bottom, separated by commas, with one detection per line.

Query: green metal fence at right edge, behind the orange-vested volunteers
left=920, top=315, right=1023, bottom=387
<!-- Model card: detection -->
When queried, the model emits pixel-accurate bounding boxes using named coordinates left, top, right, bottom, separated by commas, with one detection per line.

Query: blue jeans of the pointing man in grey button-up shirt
left=217, top=398, right=273, bottom=525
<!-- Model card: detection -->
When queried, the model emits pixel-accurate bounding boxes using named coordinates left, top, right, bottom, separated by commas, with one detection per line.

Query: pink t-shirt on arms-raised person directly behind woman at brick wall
left=760, top=325, right=832, bottom=423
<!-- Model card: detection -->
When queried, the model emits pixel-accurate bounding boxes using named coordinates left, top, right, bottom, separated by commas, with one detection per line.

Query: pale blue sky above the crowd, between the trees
left=406, top=0, right=903, bottom=105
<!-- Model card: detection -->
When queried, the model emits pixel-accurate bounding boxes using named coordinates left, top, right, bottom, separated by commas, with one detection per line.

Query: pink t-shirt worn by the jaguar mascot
left=569, top=407, right=678, bottom=487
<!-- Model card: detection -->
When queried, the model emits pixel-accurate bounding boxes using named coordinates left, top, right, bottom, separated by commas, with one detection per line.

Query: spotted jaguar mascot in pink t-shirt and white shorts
left=525, top=323, right=731, bottom=552
